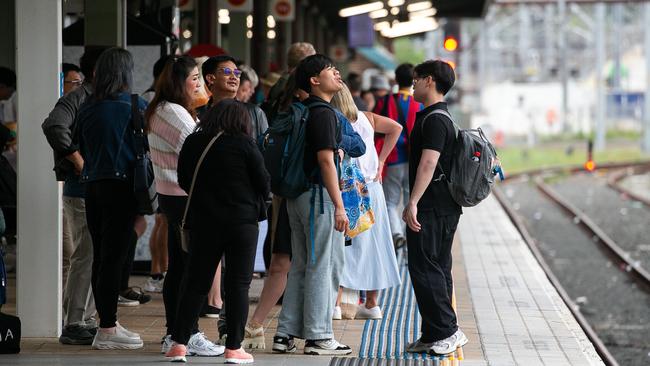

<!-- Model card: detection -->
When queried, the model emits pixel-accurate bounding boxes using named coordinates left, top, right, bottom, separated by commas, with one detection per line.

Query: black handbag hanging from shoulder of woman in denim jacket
left=131, top=94, right=158, bottom=215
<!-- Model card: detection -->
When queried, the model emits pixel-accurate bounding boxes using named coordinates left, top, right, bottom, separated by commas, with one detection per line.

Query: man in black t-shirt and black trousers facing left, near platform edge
left=403, top=60, right=467, bottom=354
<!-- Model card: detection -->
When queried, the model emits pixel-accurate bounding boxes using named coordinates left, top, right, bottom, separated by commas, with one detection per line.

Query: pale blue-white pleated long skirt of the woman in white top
left=341, top=182, right=400, bottom=291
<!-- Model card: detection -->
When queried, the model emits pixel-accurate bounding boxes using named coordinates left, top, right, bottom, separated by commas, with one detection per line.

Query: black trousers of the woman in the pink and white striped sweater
left=158, top=194, right=199, bottom=334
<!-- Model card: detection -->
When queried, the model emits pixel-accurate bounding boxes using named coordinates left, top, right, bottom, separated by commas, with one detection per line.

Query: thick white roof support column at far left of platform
left=16, top=0, right=63, bottom=337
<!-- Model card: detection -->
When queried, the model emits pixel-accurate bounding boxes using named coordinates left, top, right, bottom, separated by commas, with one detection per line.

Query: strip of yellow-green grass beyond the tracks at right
left=497, top=141, right=650, bottom=175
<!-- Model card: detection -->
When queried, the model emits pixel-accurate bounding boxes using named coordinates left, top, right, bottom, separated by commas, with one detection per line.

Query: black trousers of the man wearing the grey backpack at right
left=406, top=210, right=460, bottom=343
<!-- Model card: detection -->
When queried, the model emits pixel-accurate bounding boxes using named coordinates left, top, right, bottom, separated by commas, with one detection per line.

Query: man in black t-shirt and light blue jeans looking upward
left=273, top=54, right=352, bottom=355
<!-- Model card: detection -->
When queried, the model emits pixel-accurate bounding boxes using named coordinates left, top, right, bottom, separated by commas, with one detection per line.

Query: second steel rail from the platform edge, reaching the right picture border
left=535, top=175, right=650, bottom=289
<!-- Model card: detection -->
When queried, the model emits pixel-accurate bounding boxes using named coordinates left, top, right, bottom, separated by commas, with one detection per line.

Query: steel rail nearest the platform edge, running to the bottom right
left=492, top=187, right=619, bottom=366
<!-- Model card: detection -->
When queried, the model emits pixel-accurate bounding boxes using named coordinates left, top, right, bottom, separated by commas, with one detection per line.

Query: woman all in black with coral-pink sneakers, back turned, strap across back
left=167, top=99, right=270, bottom=364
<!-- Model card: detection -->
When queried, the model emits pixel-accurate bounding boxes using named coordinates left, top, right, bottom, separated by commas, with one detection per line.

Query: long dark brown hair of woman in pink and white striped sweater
left=144, top=56, right=196, bottom=121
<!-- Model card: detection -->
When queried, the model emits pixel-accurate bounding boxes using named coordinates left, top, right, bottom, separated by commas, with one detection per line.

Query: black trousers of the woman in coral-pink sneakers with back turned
left=172, top=222, right=259, bottom=349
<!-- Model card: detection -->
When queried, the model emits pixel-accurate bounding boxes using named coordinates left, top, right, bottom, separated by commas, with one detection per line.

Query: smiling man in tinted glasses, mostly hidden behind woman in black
left=199, top=55, right=269, bottom=141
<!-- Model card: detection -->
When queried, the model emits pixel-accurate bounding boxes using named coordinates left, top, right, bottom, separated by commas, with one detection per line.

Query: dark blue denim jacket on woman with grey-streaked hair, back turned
left=76, top=93, right=147, bottom=183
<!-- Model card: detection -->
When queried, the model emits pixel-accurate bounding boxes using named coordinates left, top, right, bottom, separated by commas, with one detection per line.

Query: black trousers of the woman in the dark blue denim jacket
left=86, top=180, right=136, bottom=328
